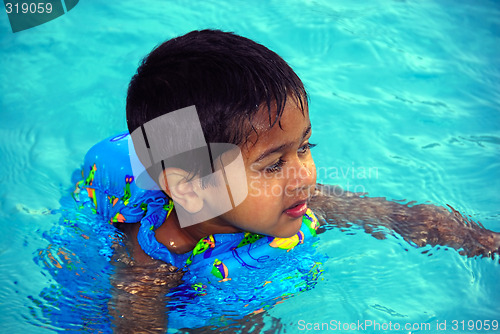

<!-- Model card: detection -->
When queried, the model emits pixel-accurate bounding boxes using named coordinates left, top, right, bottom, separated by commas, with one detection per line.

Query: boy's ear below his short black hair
left=159, top=168, right=204, bottom=214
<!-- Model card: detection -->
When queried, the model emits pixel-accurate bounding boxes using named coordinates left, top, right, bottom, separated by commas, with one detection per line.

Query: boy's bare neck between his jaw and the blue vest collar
left=155, top=210, right=241, bottom=254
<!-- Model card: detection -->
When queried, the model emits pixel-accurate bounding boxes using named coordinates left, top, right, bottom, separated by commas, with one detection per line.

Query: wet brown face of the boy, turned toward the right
left=210, top=102, right=316, bottom=238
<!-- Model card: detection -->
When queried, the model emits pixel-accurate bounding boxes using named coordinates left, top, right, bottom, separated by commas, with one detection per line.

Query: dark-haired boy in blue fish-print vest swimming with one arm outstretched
left=75, top=30, right=500, bottom=332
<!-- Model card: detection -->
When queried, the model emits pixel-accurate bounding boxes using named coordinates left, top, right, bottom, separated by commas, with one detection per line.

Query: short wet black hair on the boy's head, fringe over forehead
left=126, top=30, right=307, bottom=183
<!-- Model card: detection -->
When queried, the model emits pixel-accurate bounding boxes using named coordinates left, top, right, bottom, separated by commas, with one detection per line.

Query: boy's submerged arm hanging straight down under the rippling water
left=108, top=223, right=183, bottom=334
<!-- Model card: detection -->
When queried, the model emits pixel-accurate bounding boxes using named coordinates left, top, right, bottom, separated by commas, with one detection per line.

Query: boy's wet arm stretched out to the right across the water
left=309, top=184, right=500, bottom=258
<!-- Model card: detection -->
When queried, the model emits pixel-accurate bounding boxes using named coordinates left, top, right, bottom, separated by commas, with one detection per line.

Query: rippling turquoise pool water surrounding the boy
left=0, top=0, right=500, bottom=333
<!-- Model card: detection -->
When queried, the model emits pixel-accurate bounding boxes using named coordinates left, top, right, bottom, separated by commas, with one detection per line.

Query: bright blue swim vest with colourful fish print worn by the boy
left=74, top=133, right=322, bottom=327
